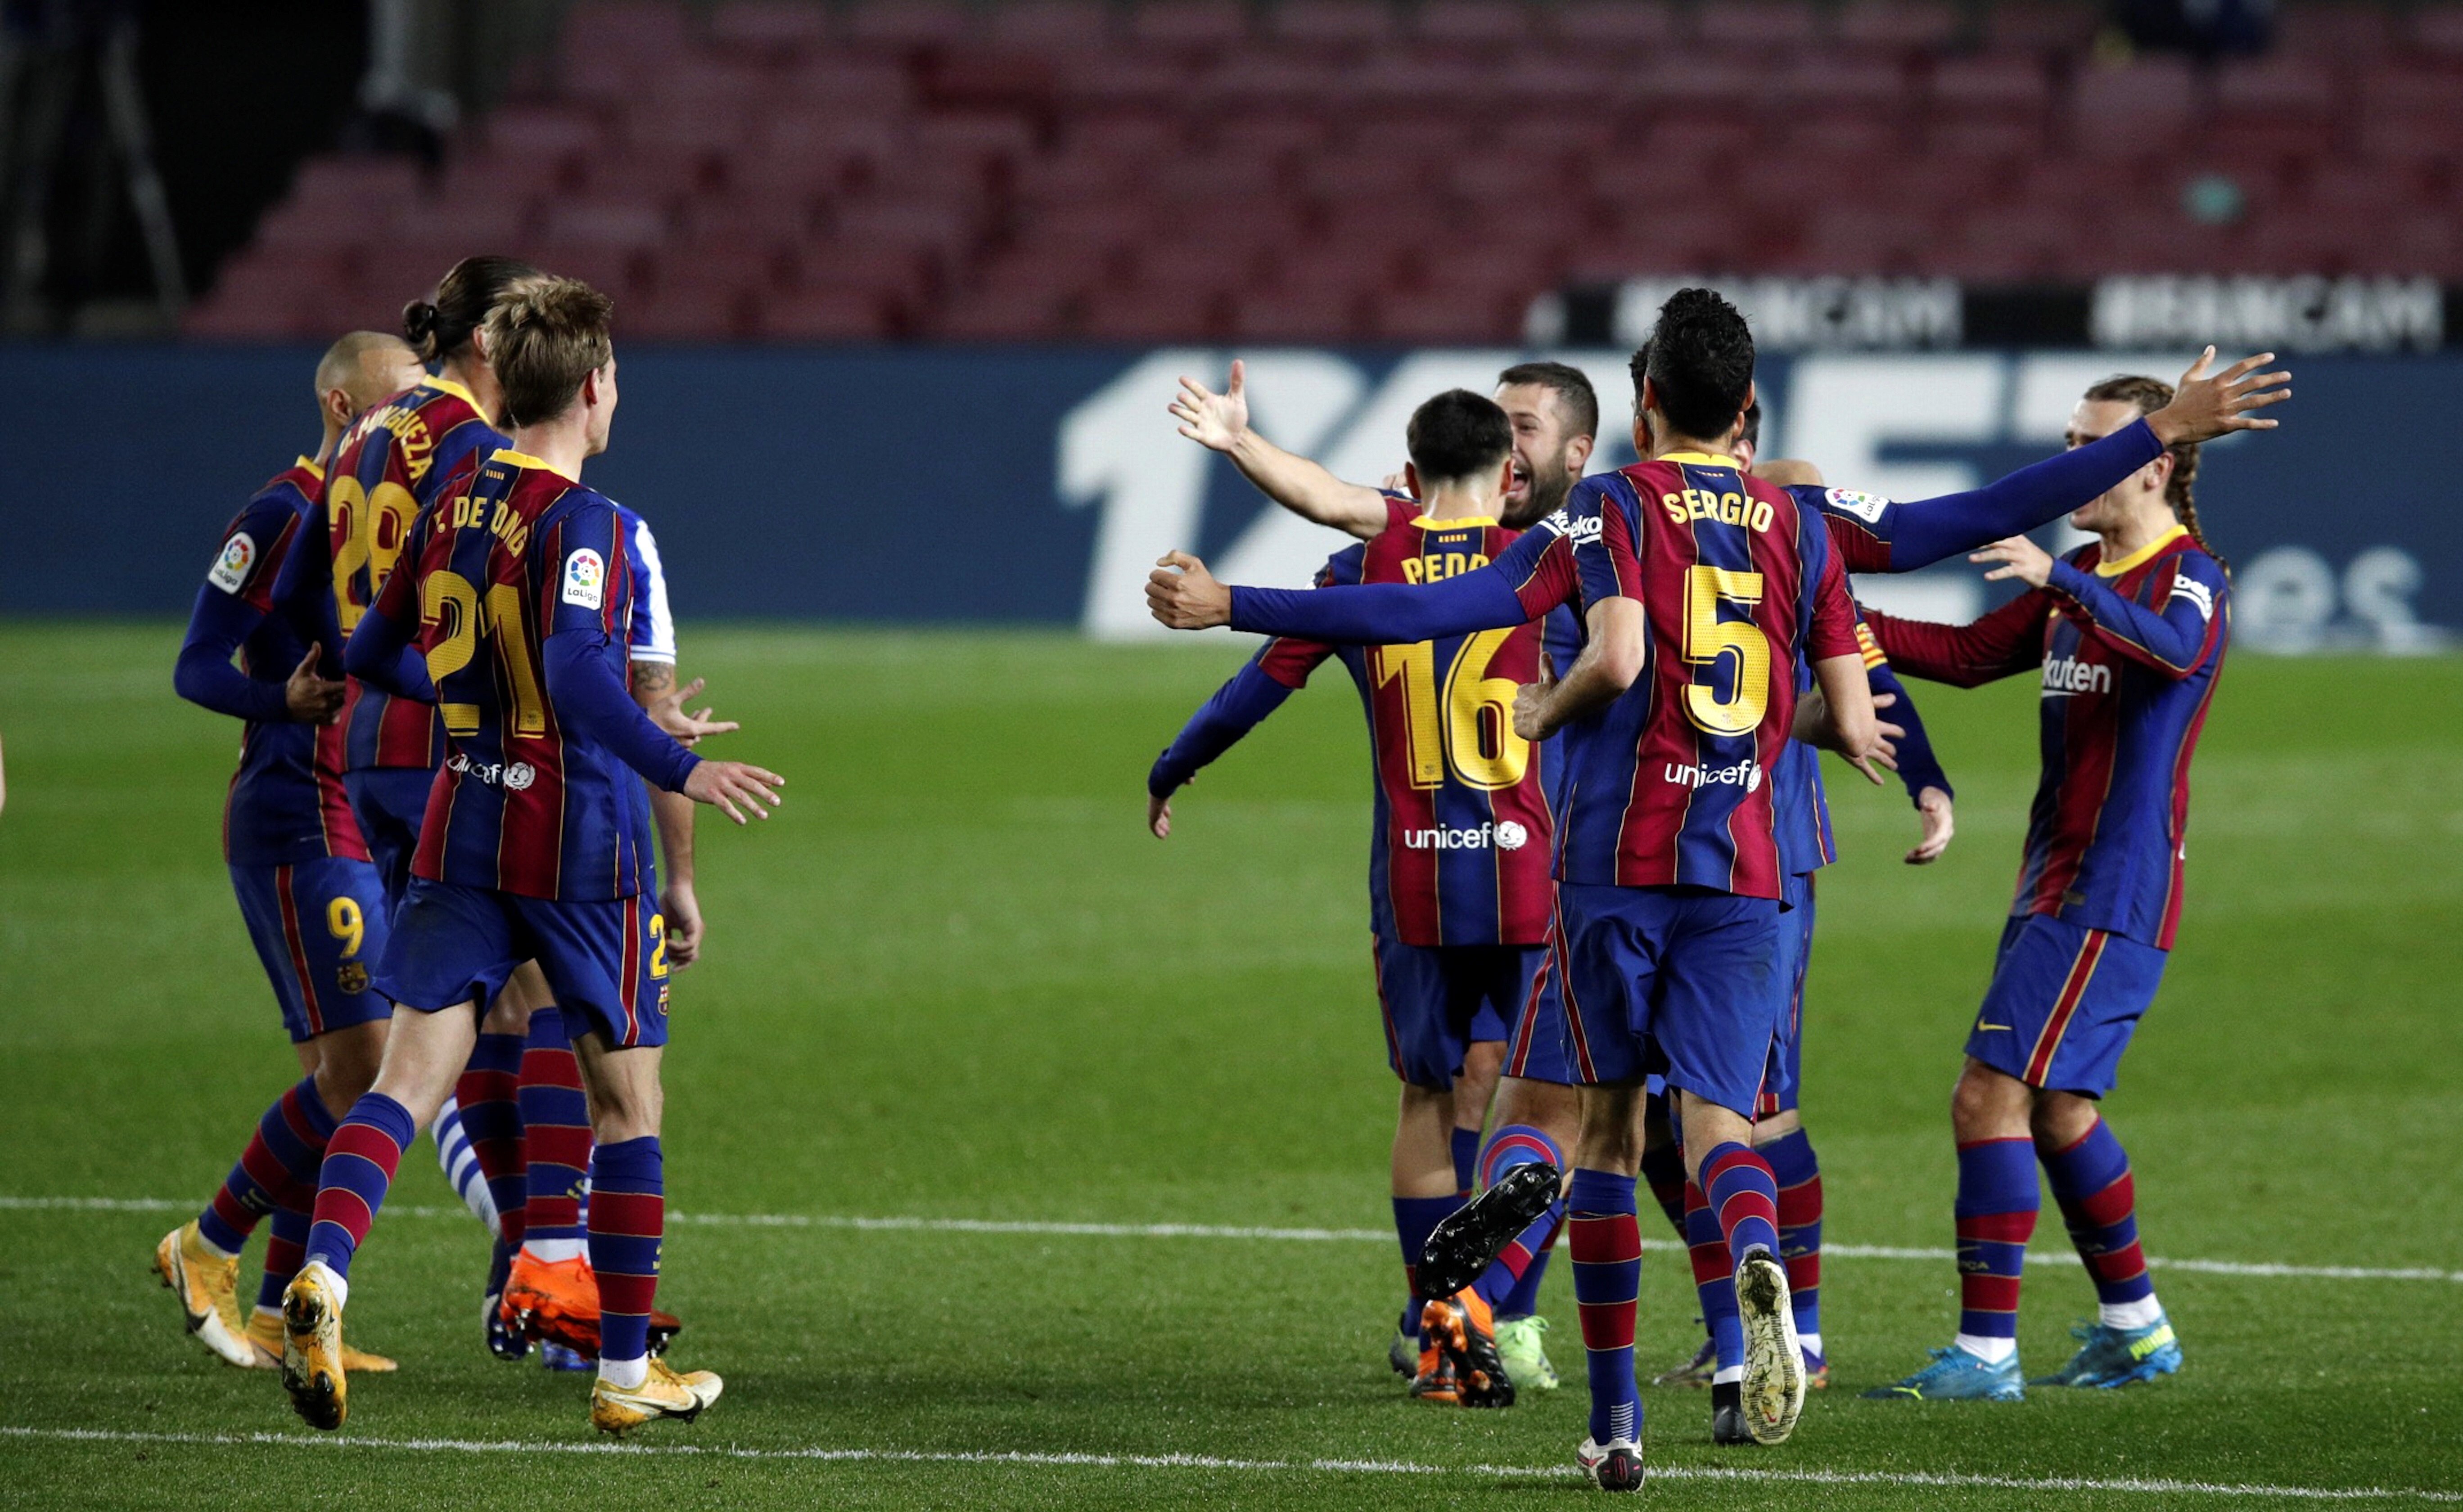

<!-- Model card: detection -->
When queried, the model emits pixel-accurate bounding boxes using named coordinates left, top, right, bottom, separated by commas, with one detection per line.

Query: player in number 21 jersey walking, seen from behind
left=283, top=278, right=781, bottom=1433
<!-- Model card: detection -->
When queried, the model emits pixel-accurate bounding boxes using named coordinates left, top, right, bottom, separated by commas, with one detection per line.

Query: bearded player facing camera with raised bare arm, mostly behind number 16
left=1150, top=362, right=1598, bottom=1391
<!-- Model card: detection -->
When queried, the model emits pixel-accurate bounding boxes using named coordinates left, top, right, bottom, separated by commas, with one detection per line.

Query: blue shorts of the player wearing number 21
left=377, top=877, right=668, bottom=1049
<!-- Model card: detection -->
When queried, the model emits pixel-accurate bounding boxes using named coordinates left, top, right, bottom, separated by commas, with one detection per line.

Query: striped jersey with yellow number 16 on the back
left=1259, top=495, right=1554, bottom=945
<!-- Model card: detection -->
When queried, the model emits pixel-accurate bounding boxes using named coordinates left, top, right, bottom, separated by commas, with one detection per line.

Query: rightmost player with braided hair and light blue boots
left=1867, top=369, right=2232, bottom=1401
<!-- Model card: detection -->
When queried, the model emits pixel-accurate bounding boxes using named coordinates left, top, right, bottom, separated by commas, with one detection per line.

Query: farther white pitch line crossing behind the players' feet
left=0, top=1197, right=2463, bottom=1283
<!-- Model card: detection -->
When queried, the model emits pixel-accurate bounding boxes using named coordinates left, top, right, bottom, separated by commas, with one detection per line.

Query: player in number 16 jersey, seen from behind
left=1148, top=392, right=1552, bottom=1406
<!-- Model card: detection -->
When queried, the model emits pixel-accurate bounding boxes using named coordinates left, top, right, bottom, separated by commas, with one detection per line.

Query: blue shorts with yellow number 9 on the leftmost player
left=231, top=857, right=394, bottom=1044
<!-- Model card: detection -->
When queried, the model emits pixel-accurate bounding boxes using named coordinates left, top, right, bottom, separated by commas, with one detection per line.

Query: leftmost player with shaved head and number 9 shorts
left=155, top=330, right=419, bottom=1369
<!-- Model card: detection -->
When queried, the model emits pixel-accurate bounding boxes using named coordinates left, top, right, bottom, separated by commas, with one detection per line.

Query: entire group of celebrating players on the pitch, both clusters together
left=155, top=259, right=2288, bottom=1490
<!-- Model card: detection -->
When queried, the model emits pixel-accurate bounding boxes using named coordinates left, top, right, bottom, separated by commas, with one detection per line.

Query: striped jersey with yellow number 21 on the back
left=374, top=450, right=650, bottom=901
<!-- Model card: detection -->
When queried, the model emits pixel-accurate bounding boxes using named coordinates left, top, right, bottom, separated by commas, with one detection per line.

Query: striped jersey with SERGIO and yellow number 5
left=1556, top=453, right=1854, bottom=899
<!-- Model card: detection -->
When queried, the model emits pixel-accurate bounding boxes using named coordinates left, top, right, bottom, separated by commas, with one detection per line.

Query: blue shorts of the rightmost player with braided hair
left=1968, top=914, right=2165, bottom=1098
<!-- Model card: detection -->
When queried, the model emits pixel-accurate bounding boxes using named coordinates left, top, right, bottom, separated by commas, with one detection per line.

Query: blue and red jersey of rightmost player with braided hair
left=1869, top=527, right=2232, bottom=950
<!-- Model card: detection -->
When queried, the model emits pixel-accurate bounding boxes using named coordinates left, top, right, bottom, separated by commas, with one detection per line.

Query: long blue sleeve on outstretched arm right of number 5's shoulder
left=1798, top=418, right=2162, bottom=572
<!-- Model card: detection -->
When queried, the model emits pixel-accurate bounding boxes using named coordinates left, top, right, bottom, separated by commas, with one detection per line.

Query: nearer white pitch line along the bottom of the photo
left=0, top=1426, right=2463, bottom=1502
